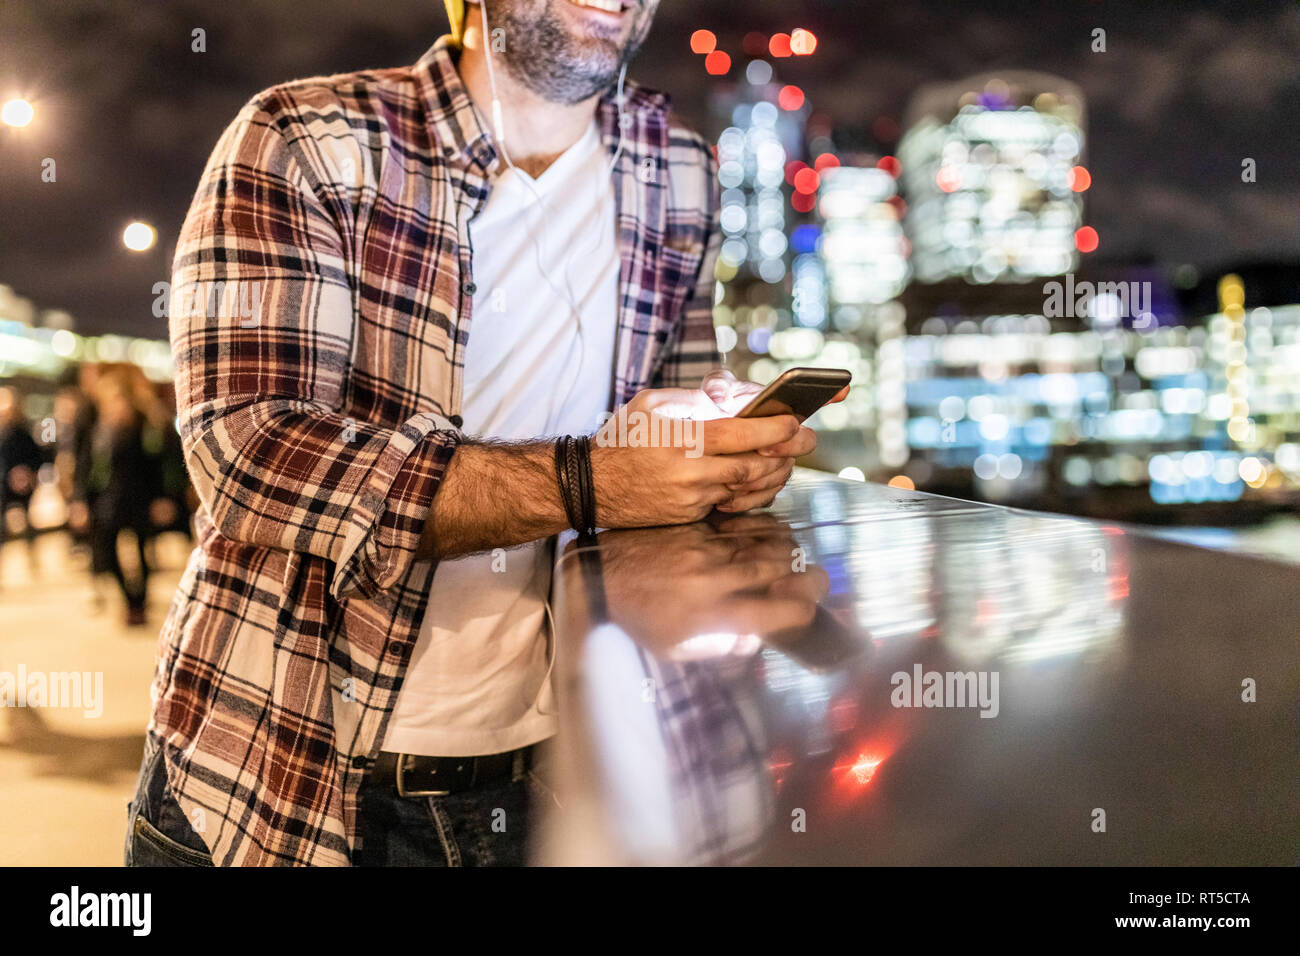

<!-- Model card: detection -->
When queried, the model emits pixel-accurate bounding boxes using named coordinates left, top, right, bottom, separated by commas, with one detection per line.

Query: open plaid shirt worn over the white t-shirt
left=150, top=38, right=719, bottom=865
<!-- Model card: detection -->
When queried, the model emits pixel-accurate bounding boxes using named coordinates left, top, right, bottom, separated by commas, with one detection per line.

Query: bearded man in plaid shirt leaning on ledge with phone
left=127, top=0, right=814, bottom=865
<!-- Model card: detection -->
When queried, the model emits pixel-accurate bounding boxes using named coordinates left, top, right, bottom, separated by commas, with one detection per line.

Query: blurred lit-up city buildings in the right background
left=714, top=55, right=1300, bottom=520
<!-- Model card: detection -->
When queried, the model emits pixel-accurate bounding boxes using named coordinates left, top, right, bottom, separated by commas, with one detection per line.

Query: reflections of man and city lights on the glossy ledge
left=560, top=483, right=1127, bottom=864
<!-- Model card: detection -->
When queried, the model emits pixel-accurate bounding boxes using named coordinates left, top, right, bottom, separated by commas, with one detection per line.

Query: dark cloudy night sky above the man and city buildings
left=0, top=0, right=1300, bottom=337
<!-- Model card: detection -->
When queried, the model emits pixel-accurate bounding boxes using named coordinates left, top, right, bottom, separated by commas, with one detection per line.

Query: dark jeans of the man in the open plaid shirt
left=126, top=736, right=550, bottom=866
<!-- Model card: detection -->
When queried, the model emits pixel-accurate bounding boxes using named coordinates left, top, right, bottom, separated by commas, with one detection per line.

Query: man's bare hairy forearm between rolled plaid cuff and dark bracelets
left=419, top=442, right=569, bottom=558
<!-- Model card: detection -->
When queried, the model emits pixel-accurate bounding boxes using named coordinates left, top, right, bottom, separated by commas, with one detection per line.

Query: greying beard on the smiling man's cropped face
left=481, top=0, right=658, bottom=105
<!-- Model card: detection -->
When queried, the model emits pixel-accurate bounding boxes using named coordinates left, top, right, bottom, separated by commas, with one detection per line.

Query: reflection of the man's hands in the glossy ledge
left=599, top=515, right=829, bottom=659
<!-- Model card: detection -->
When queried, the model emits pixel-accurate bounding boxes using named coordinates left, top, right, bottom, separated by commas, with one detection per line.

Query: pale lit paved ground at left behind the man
left=0, top=535, right=189, bottom=866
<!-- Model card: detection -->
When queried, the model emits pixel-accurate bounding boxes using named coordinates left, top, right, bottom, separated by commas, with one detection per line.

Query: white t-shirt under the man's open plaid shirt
left=384, top=120, right=619, bottom=757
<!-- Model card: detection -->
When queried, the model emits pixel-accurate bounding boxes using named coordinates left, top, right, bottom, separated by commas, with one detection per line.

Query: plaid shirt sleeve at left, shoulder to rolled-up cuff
left=170, top=100, right=459, bottom=598
